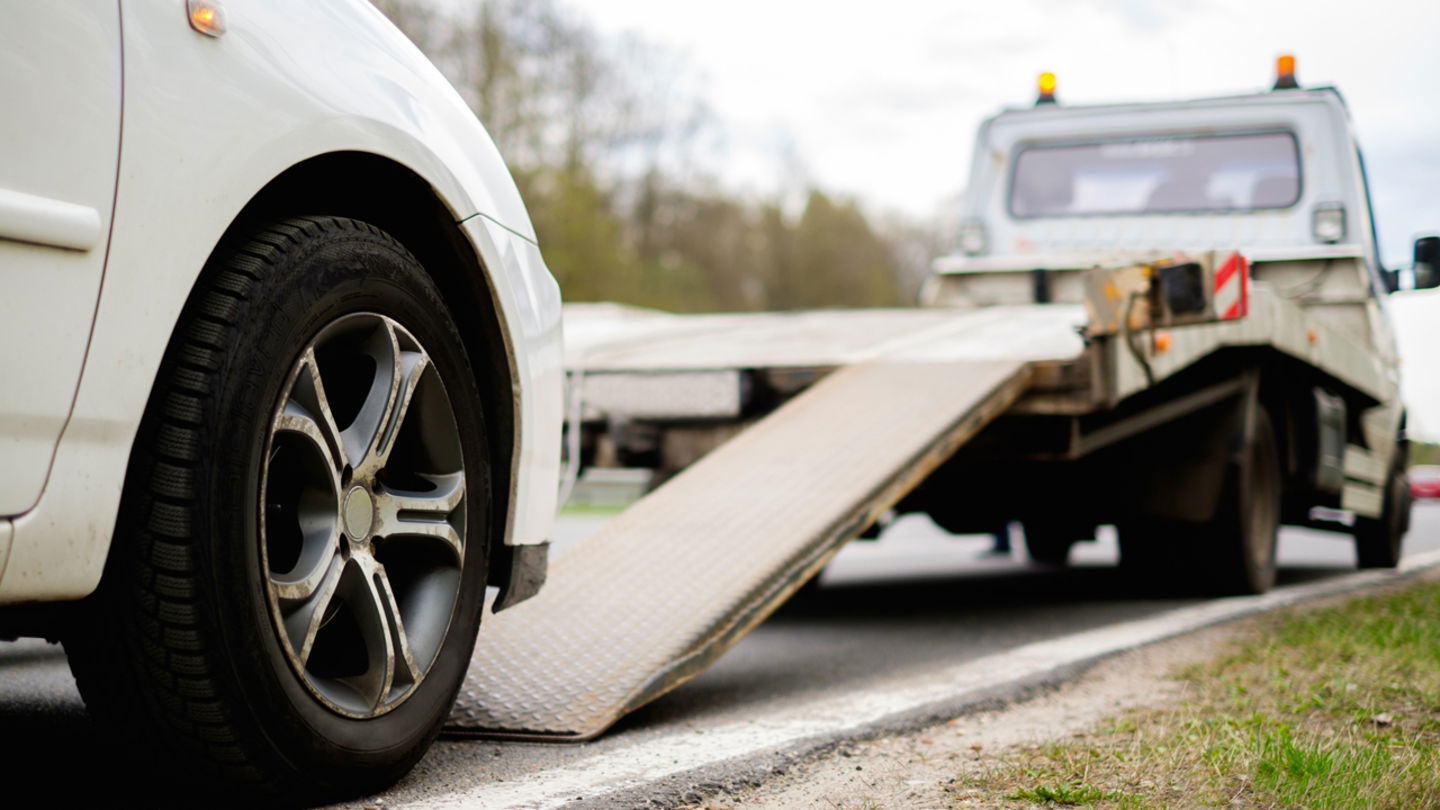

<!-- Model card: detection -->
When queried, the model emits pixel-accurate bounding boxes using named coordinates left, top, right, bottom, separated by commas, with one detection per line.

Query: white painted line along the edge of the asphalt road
left=390, top=549, right=1440, bottom=810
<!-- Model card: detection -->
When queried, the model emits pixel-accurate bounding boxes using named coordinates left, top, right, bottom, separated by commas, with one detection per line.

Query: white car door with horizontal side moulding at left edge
left=0, top=0, right=122, bottom=516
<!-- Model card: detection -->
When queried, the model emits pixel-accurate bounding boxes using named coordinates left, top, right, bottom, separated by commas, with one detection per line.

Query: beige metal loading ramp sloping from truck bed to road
left=446, top=360, right=1028, bottom=741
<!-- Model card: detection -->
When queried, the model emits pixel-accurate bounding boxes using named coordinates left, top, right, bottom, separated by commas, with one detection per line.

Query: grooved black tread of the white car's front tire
left=66, top=216, right=405, bottom=796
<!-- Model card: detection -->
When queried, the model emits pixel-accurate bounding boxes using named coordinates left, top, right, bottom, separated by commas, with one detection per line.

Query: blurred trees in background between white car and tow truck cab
left=373, top=0, right=939, bottom=311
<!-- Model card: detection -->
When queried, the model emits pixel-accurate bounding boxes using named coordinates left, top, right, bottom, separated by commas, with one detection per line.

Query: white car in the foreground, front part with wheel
left=0, top=0, right=562, bottom=797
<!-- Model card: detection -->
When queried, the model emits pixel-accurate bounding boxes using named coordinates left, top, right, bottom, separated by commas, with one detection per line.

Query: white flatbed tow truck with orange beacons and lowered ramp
left=449, top=62, right=1440, bottom=739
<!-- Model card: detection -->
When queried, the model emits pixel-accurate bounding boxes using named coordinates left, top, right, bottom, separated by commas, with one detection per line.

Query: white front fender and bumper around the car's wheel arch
left=0, top=0, right=562, bottom=602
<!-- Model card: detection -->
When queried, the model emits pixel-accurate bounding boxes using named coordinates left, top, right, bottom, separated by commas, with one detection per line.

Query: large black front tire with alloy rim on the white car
left=65, top=216, right=491, bottom=801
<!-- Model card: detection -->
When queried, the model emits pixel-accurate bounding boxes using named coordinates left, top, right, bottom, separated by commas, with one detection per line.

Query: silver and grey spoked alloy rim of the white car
left=259, top=313, right=467, bottom=718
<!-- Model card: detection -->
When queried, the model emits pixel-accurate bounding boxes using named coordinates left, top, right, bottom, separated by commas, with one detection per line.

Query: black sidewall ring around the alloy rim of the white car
left=196, top=221, right=490, bottom=788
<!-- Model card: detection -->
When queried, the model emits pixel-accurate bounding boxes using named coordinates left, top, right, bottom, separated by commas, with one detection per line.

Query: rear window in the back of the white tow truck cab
left=1009, top=133, right=1300, bottom=218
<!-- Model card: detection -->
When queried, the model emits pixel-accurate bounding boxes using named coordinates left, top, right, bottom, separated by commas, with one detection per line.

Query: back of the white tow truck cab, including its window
left=936, top=88, right=1375, bottom=272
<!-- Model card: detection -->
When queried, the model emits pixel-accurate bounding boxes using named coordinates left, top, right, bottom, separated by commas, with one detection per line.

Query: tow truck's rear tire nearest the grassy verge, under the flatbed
left=1197, top=406, right=1282, bottom=594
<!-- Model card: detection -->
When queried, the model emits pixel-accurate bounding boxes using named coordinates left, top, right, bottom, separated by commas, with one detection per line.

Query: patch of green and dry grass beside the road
left=950, top=582, right=1440, bottom=810
